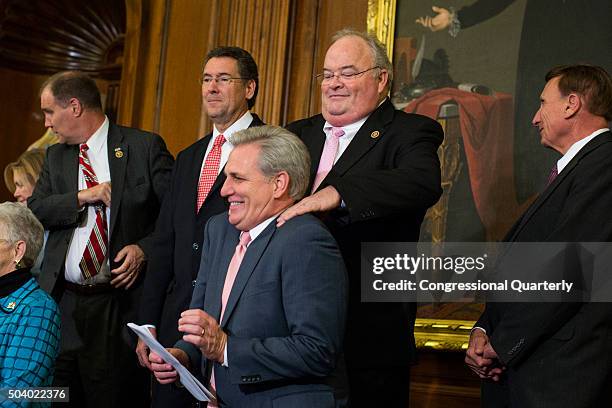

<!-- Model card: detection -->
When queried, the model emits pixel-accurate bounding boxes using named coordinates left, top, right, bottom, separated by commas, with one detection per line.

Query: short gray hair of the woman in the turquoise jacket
left=0, top=202, right=44, bottom=268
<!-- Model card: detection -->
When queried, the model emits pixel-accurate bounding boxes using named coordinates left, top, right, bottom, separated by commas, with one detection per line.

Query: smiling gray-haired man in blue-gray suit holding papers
left=151, top=126, right=347, bottom=408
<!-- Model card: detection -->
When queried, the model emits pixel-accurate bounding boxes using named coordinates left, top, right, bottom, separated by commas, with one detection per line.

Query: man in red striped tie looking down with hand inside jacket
left=28, top=72, right=173, bottom=407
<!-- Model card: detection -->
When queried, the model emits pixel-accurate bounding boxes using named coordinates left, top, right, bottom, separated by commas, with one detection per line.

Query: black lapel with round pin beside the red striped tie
left=107, top=123, right=129, bottom=240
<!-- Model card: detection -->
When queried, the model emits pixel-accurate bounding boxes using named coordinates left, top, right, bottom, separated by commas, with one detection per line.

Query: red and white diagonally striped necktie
left=79, top=144, right=108, bottom=279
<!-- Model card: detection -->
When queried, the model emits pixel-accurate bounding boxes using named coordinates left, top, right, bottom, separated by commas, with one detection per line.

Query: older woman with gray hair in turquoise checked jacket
left=0, top=202, right=60, bottom=396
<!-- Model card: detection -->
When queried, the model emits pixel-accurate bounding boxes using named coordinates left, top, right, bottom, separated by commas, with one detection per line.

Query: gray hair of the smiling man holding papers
left=230, top=126, right=310, bottom=201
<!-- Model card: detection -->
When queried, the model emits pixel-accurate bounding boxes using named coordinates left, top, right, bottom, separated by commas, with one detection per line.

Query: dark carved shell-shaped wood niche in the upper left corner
left=0, top=0, right=125, bottom=80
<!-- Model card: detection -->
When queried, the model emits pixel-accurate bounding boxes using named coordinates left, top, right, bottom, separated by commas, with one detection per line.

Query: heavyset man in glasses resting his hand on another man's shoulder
left=279, top=30, right=443, bottom=407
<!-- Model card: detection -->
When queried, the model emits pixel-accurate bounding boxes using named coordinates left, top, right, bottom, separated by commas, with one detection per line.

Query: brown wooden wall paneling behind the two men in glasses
left=120, top=0, right=367, bottom=153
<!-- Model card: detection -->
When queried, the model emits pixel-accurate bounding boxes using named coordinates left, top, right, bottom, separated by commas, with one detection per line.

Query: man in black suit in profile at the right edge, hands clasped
left=466, top=65, right=612, bottom=408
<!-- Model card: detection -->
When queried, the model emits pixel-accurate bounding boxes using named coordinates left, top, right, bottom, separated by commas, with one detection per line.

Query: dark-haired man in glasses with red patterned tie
left=136, top=47, right=263, bottom=407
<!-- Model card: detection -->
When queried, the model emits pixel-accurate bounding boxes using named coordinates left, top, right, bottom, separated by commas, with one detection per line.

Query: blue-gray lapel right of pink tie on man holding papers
left=218, top=221, right=276, bottom=327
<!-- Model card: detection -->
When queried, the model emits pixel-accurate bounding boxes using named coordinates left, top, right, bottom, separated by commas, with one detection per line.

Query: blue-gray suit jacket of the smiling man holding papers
left=177, top=213, right=347, bottom=407
